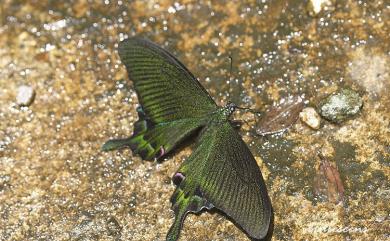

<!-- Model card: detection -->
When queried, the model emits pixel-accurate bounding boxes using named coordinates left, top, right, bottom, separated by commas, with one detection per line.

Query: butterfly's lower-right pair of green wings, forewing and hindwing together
left=171, top=122, right=273, bottom=240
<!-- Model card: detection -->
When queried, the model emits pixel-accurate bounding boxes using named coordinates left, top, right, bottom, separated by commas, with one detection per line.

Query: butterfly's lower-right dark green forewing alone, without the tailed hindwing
left=200, top=123, right=272, bottom=239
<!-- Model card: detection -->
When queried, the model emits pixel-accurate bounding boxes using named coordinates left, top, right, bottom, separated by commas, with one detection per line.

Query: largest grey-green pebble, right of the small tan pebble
left=318, top=88, right=363, bottom=124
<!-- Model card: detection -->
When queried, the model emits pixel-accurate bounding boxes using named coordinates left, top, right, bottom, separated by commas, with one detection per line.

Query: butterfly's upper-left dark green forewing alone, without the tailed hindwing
left=118, top=37, right=217, bottom=123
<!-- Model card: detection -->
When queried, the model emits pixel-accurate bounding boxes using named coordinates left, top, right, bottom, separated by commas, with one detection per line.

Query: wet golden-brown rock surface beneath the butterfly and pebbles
left=0, top=0, right=390, bottom=241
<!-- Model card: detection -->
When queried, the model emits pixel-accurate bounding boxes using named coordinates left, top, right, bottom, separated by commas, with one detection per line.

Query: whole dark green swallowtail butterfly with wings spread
left=102, top=37, right=273, bottom=241
